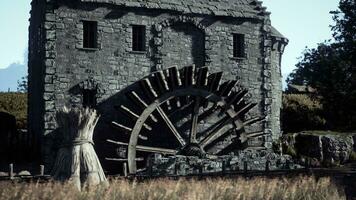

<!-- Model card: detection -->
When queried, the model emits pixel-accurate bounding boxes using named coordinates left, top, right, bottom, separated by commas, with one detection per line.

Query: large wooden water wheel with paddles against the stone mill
left=107, top=66, right=265, bottom=174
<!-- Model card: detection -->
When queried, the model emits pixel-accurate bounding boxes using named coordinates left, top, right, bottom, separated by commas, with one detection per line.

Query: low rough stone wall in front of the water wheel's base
left=145, top=150, right=301, bottom=176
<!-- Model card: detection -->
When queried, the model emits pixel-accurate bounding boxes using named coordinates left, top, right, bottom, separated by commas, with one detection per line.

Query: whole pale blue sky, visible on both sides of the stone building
left=0, top=0, right=338, bottom=86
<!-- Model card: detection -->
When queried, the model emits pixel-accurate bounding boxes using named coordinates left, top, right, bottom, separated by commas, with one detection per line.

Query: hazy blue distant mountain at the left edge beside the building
left=0, top=63, right=27, bottom=92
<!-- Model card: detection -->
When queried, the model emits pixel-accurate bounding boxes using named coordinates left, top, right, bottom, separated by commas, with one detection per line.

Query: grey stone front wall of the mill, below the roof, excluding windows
left=30, top=1, right=281, bottom=170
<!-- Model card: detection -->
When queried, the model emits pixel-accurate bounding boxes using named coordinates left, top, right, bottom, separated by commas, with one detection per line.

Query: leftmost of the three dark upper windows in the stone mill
left=83, top=21, right=98, bottom=48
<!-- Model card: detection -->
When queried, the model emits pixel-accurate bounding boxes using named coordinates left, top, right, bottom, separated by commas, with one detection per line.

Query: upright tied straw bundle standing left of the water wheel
left=52, top=107, right=108, bottom=190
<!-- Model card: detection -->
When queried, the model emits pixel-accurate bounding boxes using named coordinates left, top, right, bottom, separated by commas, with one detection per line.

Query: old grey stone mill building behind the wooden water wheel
left=29, top=0, right=288, bottom=170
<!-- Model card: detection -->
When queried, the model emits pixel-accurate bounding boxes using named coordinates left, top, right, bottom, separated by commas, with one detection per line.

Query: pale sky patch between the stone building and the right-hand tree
left=263, top=0, right=339, bottom=82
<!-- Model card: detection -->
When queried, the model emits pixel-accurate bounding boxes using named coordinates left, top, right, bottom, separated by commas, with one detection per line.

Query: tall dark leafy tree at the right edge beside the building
left=287, top=0, right=356, bottom=129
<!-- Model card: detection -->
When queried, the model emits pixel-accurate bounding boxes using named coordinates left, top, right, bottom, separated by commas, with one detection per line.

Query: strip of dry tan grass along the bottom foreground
left=0, top=177, right=345, bottom=200
